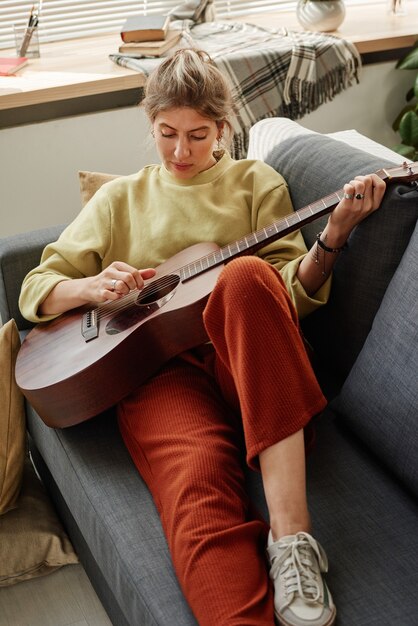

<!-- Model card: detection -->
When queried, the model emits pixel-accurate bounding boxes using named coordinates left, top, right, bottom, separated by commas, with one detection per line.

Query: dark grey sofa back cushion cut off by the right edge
left=333, top=225, right=418, bottom=495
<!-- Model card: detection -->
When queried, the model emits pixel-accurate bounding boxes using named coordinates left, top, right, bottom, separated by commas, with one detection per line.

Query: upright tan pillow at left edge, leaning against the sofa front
left=0, top=320, right=26, bottom=514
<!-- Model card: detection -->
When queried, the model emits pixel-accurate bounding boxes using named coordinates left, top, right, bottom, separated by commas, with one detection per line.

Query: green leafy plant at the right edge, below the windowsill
left=392, top=42, right=418, bottom=161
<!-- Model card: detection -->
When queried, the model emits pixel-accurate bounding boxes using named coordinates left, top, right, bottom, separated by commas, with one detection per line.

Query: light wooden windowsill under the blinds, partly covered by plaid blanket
left=0, top=2, right=418, bottom=128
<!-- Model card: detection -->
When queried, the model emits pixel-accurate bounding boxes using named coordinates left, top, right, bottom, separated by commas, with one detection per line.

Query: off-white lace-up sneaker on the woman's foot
left=267, top=531, right=336, bottom=626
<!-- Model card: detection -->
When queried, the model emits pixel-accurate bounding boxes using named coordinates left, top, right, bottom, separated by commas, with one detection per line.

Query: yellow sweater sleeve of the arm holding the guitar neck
left=257, top=179, right=331, bottom=319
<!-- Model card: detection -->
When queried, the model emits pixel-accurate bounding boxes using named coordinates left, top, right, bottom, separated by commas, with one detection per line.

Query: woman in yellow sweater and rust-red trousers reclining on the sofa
left=20, top=50, right=384, bottom=626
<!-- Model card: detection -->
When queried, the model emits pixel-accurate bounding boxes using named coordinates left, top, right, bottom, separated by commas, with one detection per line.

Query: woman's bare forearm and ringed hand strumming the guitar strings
left=38, top=261, right=155, bottom=315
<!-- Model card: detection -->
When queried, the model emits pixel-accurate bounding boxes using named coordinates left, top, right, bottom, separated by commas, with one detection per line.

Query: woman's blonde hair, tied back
left=141, top=48, right=235, bottom=139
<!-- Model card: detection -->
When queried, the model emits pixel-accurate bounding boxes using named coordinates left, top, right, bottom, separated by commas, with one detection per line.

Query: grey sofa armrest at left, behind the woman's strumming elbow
left=0, top=225, right=64, bottom=330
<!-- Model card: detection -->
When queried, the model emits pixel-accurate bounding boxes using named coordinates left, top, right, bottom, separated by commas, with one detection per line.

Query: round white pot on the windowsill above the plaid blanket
left=296, top=0, right=345, bottom=32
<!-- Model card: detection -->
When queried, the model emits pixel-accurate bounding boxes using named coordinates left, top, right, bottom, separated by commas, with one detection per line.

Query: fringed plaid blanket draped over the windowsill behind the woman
left=109, top=22, right=361, bottom=158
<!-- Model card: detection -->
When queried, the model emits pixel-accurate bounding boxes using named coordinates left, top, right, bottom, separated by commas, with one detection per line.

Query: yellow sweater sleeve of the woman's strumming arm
left=19, top=190, right=111, bottom=322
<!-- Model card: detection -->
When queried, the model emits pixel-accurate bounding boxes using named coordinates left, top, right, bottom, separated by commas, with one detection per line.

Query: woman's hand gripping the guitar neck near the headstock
left=326, top=174, right=386, bottom=247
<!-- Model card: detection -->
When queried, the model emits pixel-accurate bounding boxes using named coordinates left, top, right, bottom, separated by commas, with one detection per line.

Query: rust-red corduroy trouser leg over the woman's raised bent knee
left=204, top=257, right=326, bottom=469
